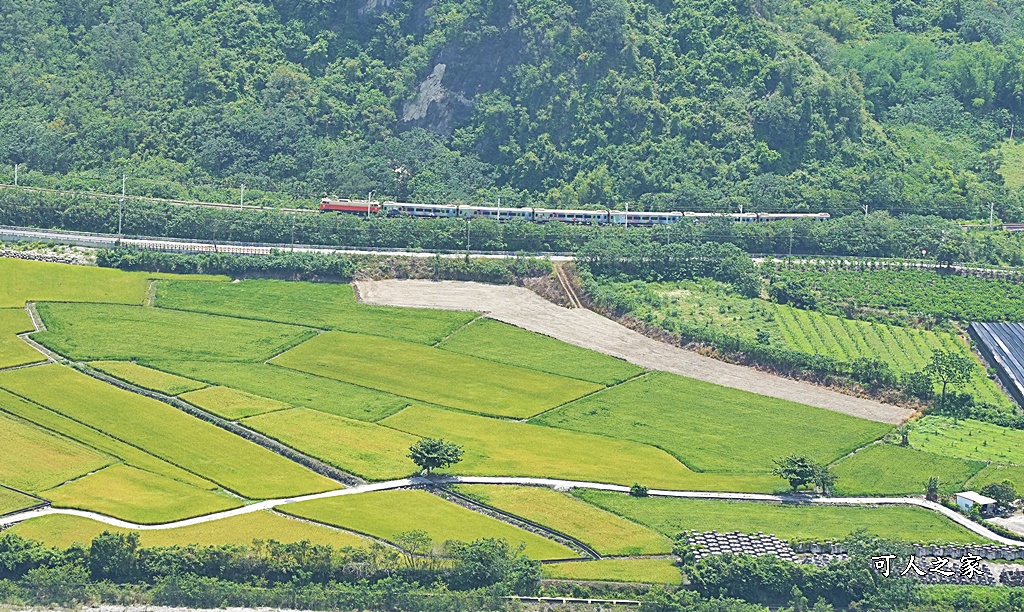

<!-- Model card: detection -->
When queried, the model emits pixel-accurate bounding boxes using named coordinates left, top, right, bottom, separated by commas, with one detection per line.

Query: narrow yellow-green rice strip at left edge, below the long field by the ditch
left=0, top=389, right=217, bottom=490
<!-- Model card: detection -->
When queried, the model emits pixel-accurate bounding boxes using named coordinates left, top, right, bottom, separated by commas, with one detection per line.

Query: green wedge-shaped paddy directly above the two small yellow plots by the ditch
left=151, top=361, right=409, bottom=421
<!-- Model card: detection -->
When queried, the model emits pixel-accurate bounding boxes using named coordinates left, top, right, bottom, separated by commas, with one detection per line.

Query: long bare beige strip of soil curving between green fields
left=356, top=280, right=912, bottom=424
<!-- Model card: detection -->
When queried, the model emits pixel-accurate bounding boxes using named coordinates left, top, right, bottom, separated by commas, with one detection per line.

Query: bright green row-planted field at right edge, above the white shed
left=910, top=417, right=1024, bottom=466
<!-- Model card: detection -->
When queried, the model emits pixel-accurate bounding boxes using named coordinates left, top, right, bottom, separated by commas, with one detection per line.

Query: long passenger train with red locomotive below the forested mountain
left=319, top=198, right=830, bottom=226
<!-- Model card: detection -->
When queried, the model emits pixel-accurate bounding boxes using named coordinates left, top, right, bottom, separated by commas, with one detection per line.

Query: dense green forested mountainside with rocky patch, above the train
left=0, top=0, right=1024, bottom=219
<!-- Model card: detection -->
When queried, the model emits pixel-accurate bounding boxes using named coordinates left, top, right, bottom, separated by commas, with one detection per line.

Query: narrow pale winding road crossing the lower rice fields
left=0, top=476, right=1024, bottom=547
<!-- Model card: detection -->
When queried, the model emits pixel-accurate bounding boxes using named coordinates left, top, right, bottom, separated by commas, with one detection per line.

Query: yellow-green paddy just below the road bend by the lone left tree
left=282, top=490, right=577, bottom=560
